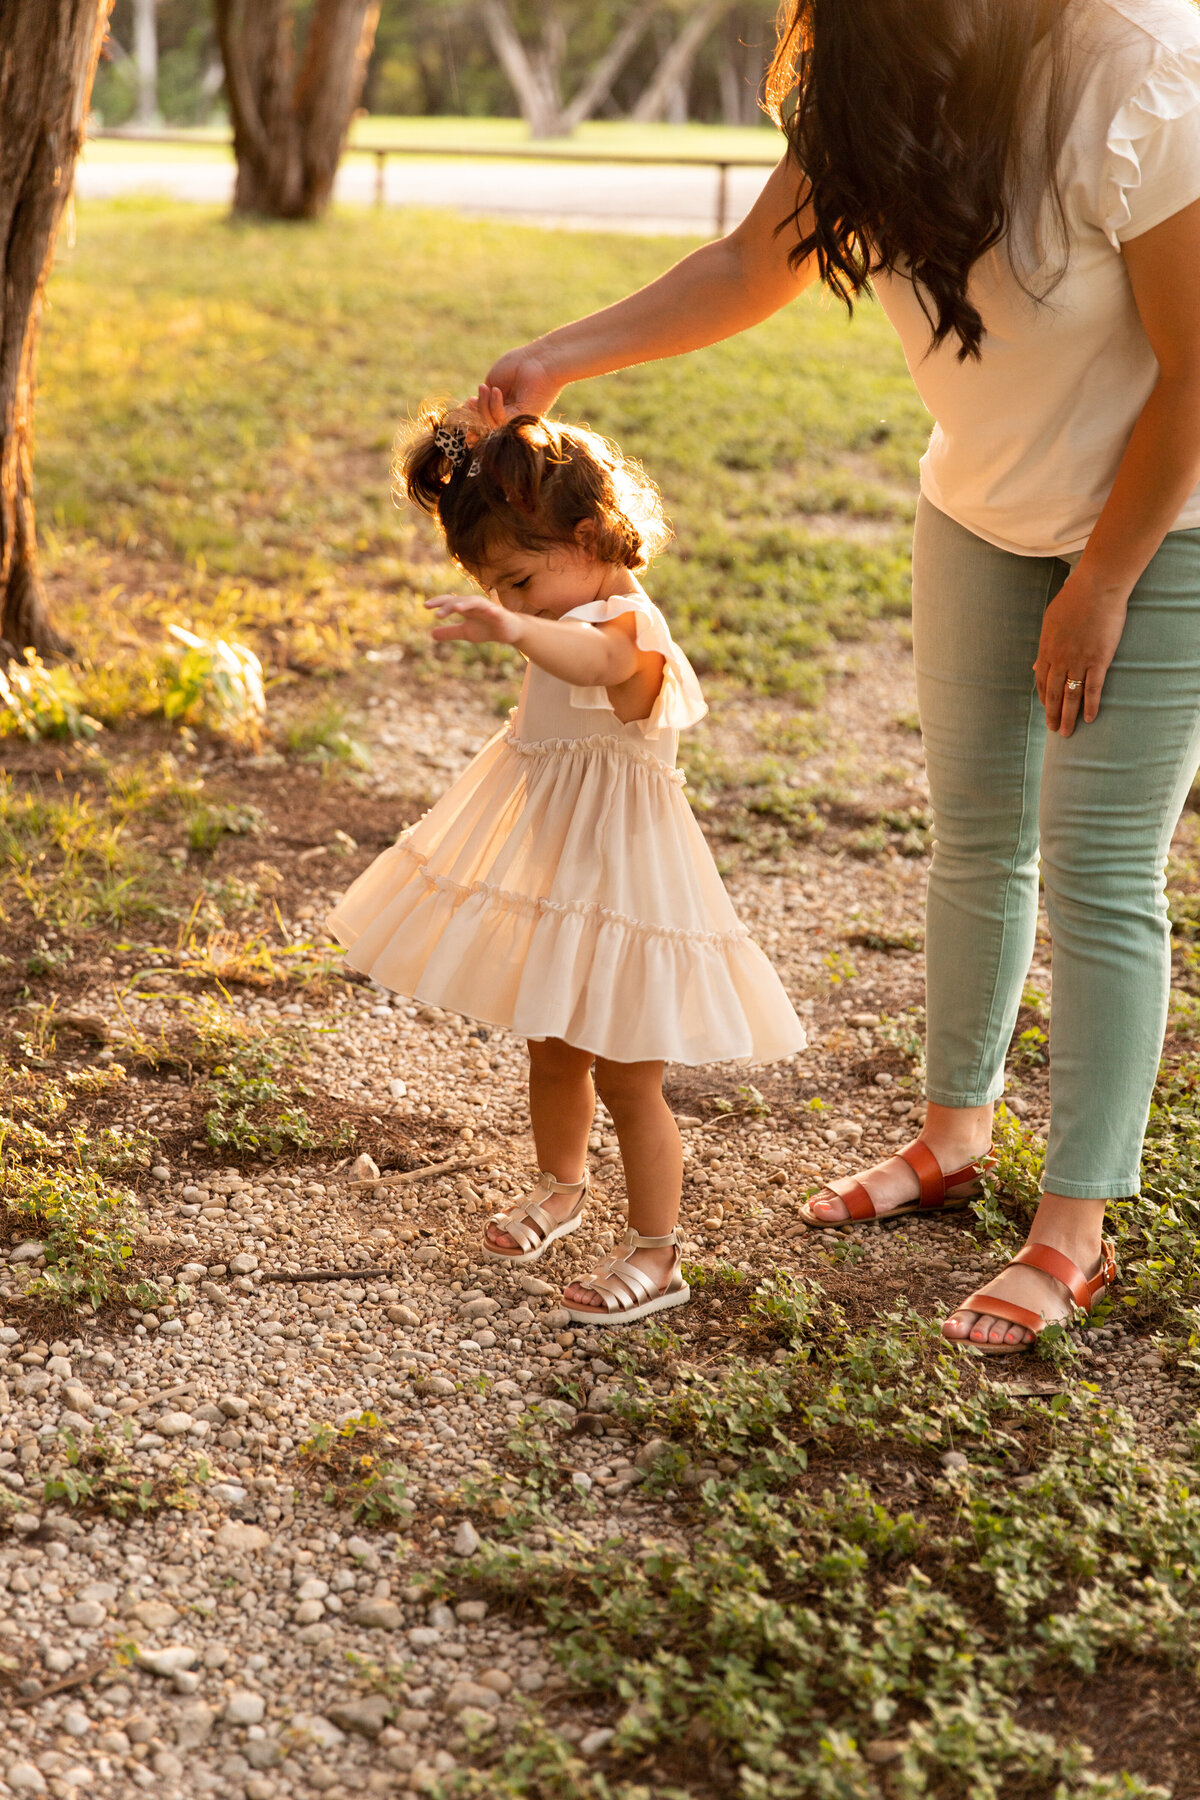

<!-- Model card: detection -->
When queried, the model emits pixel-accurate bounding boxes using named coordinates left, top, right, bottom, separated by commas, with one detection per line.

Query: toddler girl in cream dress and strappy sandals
left=329, top=389, right=804, bottom=1325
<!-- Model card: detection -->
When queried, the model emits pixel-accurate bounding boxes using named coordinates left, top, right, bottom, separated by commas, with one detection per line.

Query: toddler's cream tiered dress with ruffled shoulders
left=329, top=592, right=804, bottom=1064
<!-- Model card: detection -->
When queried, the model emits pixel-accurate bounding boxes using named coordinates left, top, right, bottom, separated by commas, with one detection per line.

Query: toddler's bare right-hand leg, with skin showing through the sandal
left=563, top=1057, right=684, bottom=1309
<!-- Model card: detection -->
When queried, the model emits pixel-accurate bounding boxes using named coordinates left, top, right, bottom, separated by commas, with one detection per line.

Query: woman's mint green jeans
left=912, top=500, right=1200, bottom=1199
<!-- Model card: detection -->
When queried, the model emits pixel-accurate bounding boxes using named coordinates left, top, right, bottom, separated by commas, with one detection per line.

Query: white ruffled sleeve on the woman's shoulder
left=1099, top=45, right=1200, bottom=247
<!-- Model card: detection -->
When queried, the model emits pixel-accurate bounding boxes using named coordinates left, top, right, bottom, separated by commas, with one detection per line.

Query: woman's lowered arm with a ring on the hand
left=1034, top=200, right=1200, bottom=738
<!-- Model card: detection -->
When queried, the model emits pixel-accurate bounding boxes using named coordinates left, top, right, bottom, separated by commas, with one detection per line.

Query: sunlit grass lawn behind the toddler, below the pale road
left=38, top=202, right=927, bottom=698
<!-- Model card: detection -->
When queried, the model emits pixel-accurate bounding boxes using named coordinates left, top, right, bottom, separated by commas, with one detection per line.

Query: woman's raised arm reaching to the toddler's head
left=488, top=157, right=817, bottom=412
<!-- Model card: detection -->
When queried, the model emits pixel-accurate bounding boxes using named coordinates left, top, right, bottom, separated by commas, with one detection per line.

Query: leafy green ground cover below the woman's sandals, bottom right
left=429, top=1276, right=1200, bottom=1800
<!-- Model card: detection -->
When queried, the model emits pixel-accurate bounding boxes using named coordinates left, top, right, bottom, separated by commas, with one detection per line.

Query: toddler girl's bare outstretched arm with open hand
left=425, top=594, right=664, bottom=698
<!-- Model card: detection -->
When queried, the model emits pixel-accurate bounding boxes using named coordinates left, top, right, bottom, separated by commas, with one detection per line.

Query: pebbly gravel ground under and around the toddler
left=0, top=622, right=1195, bottom=1800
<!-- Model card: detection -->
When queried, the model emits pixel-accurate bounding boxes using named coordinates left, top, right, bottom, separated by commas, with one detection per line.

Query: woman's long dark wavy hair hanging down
left=766, top=0, right=1065, bottom=360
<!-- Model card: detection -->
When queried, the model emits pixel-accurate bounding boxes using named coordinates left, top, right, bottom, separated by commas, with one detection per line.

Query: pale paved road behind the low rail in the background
left=76, top=146, right=768, bottom=238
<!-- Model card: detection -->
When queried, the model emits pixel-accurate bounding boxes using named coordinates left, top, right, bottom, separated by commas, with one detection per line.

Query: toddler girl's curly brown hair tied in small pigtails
left=394, top=403, right=671, bottom=571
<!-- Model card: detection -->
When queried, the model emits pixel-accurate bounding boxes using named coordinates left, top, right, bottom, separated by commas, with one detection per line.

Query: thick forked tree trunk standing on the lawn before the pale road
left=214, top=0, right=380, bottom=220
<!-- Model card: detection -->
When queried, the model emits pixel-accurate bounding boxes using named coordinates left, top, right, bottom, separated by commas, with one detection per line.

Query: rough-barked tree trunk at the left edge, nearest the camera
left=0, top=0, right=112, bottom=657
